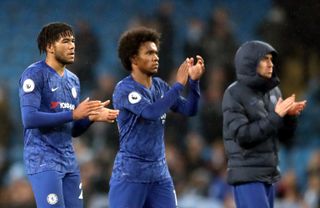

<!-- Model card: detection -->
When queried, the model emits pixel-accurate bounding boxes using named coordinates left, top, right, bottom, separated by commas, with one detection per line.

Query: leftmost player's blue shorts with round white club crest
left=28, top=171, right=83, bottom=208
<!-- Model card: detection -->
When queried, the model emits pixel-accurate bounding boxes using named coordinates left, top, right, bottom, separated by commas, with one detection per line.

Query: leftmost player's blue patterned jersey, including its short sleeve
left=19, top=61, right=80, bottom=174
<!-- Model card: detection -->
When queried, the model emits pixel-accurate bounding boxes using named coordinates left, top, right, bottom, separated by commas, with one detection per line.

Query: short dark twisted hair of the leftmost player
left=37, top=22, right=74, bottom=54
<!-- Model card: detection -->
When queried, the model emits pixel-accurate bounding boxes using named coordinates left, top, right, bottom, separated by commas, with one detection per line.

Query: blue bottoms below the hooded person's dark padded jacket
left=233, top=182, right=275, bottom=208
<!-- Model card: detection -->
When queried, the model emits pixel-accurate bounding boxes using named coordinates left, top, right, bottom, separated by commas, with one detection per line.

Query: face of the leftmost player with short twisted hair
left=52, top=36, right=75, bottom=65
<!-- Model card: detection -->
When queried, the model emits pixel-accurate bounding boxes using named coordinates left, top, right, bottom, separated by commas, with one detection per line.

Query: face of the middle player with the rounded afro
left=134, top=41, right=159, bottom=76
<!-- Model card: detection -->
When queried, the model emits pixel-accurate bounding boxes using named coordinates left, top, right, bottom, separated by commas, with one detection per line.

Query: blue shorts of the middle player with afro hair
left=109, top=179, right=177, bottom=208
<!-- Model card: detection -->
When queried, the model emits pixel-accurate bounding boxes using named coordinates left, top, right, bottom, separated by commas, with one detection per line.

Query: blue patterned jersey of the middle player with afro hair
left=111, top=76, right=174, bottom=182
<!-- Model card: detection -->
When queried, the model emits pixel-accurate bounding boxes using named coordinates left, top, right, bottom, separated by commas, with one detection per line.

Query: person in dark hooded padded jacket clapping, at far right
left=222, top=41, right=306, bottom=208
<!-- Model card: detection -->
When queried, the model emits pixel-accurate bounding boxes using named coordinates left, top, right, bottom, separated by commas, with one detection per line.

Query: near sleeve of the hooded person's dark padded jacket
left=222, top=88, right=283, bottom=148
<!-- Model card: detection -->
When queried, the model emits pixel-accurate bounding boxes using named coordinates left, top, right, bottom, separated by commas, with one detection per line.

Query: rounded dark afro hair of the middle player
left=118, top=27, right=161, bottom=71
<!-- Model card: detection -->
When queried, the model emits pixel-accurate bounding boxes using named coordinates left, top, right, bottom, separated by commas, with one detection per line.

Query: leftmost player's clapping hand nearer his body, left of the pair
left=72, top=98, right=104, bottom=120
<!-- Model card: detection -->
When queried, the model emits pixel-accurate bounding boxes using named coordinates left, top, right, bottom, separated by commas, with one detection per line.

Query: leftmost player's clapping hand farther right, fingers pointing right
left=89, top=100, right=119, bottom=123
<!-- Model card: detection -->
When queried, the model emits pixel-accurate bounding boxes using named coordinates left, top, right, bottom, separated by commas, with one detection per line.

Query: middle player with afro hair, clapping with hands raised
left=109, top=27, right=205, bottom=208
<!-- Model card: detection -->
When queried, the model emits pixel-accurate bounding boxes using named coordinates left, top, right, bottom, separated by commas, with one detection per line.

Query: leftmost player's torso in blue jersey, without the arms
left=24, top=63, right=79, bottom=173
